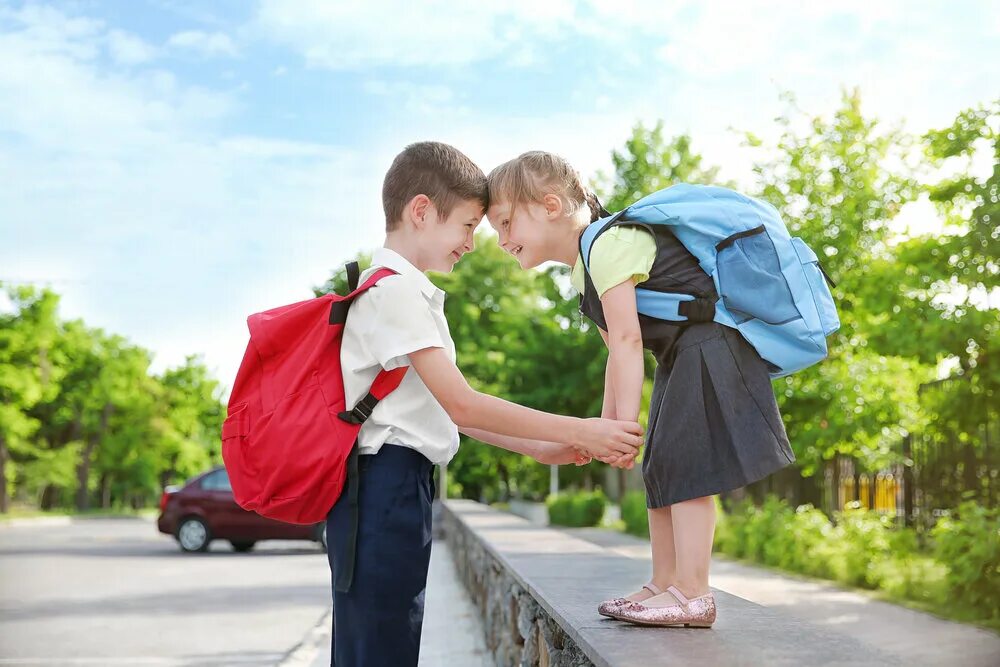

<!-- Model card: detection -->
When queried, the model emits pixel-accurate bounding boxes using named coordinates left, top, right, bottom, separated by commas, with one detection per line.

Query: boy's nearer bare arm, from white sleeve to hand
left=409, top=347, right=642, bottom=456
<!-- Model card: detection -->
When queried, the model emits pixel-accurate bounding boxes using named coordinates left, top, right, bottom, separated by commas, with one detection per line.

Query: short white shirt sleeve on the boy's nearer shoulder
left=365, top=277, right=446, bottom=371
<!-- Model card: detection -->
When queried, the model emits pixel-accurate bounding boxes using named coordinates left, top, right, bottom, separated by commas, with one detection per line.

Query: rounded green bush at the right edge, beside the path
left=931, top=502, right=1000, bottom=620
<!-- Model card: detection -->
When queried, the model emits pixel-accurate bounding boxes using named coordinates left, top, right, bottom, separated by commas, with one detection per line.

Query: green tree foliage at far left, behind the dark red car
left=0, top=286, right=222, bottom=511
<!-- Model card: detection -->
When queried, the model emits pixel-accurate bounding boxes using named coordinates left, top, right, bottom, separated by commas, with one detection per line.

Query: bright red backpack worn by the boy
left=222, top=262, right=406, bottom=524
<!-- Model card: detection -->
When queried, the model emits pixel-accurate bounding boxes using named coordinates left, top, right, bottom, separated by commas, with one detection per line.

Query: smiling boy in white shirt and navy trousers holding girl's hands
left=327, top=142, right=642, bottom=667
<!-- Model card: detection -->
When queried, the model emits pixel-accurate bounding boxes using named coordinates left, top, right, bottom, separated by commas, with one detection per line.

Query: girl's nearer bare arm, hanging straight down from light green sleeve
left=601, top=280, right=645, bottom=421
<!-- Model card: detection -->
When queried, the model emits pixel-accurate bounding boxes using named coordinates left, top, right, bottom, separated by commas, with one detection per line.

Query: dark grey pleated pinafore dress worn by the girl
left=580, top=221, right=795, bottom=508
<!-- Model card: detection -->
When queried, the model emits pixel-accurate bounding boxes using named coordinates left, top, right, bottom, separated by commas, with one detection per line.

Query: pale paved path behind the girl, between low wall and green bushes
left=561, top=528, right=1000, bottom=667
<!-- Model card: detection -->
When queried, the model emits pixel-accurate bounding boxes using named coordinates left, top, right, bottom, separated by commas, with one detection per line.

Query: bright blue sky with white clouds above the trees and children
left=0, top=0, right=1000, bottom=394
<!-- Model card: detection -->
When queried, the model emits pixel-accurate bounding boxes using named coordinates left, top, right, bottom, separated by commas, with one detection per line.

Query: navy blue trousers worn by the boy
left=326, top=444, right=434, bottom=667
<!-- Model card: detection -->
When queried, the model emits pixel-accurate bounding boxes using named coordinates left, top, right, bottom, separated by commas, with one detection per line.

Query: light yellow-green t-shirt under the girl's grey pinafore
left=570, top=227, right=656, bottom=296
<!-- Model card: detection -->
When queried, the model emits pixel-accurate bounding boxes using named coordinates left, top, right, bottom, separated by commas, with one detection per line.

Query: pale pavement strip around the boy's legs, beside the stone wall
left=311, top=540, right=493, bottom=667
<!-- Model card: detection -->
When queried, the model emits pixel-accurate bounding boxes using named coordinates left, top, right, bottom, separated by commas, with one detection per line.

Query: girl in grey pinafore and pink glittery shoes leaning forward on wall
left=487, top=151, right=795, bottom=627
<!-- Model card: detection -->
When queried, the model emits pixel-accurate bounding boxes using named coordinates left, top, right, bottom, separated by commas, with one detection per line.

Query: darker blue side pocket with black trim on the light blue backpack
left=715, top=225, right=802, bottom=324
